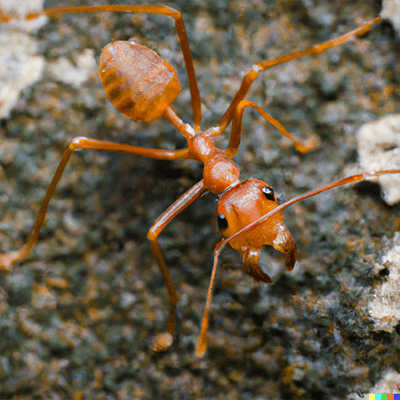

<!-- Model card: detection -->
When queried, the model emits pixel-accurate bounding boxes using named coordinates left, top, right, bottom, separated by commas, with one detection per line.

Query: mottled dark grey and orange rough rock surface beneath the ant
left=0, top=0, right=400, bottom=400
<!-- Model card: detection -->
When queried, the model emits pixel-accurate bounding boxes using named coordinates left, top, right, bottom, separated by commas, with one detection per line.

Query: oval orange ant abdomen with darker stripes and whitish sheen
left=100, top=41, right=180, bottom=122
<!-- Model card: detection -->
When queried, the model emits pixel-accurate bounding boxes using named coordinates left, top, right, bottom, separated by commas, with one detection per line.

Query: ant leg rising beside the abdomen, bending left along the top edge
left=0, top=5, right=201, bottom=132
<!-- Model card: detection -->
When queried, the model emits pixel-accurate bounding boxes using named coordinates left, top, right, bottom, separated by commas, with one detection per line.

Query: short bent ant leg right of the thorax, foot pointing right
left=225, top=100, right=320, bottom=158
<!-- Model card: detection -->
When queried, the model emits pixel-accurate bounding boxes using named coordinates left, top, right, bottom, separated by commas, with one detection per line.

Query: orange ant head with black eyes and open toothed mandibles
left=217, top=178, right=297, bottom=282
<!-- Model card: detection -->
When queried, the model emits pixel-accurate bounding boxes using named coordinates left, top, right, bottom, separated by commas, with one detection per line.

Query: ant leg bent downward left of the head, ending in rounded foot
left=147, top=180, right=206, bottom=351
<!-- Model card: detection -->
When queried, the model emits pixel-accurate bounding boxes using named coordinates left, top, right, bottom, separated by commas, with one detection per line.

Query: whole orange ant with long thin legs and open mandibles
left=0, top=5, right=400, bottom=356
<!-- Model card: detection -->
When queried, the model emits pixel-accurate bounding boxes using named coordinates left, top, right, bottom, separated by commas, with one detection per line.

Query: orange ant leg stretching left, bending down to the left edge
left=0, top=137, right=189, bottom=271
